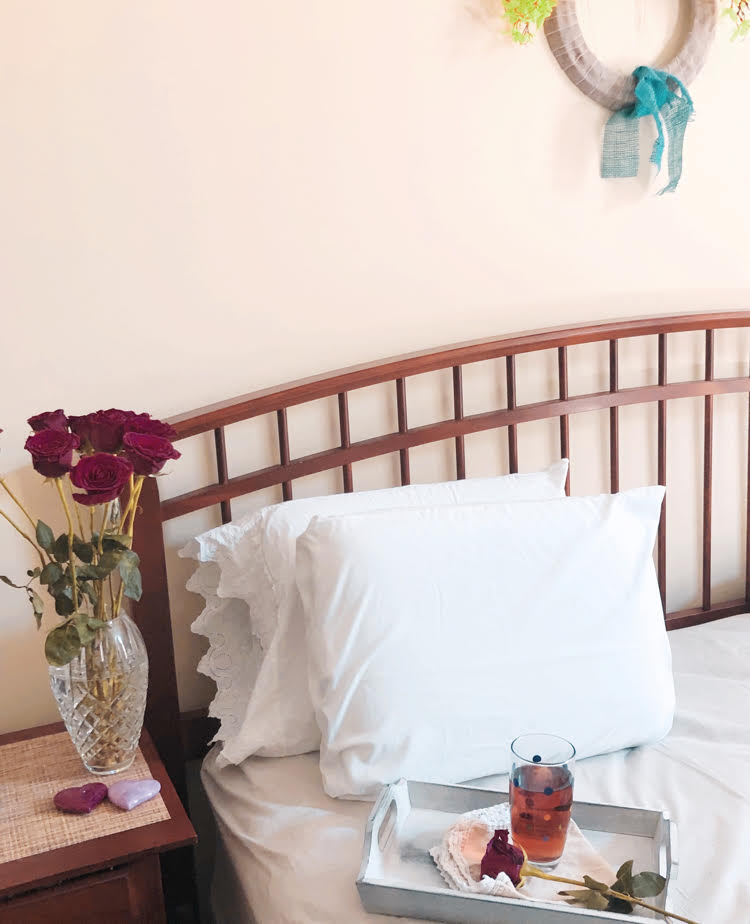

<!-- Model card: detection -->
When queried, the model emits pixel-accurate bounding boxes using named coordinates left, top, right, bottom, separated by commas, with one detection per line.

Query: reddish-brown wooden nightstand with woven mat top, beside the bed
left=0, top=724, right=197, bottom=924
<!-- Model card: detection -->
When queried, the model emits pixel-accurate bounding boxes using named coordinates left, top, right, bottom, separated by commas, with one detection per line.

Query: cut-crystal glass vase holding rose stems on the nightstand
left=49, top=611, right=148, bottom=774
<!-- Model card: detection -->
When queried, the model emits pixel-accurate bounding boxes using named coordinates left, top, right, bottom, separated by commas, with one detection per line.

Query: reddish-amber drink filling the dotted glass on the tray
left=510, top=765, right=573, bottom=863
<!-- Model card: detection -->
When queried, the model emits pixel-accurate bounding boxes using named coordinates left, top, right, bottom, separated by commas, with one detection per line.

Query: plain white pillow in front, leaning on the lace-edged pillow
left=297, top=487, right=674, bottom=799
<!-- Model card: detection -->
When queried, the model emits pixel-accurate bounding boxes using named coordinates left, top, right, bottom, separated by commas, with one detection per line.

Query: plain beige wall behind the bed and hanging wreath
left=0, top=0, right=750, bottom=730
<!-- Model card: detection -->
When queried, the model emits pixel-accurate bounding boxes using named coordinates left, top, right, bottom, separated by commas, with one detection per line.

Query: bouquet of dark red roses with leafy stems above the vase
left=0, top=408, right=180, bottom=666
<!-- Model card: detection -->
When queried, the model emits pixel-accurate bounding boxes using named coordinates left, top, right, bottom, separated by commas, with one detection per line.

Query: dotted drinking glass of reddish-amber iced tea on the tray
left=510, top=735, right=576, bottom=869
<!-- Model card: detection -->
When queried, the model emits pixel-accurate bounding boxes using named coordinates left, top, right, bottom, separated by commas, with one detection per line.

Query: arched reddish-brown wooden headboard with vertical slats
left=135, top=311, right=750, bottom=797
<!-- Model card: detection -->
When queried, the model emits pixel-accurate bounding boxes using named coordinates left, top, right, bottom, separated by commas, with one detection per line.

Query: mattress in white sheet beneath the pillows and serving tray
left=203, top=614, right=750, bottom=924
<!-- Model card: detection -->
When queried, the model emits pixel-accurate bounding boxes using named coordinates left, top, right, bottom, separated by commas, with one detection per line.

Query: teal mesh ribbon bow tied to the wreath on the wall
left=602, top=67, right=693, bottom=196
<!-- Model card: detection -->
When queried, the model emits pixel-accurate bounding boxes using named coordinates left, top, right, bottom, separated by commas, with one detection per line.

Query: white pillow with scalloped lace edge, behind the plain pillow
left=180, top=459, right=568, bottom=763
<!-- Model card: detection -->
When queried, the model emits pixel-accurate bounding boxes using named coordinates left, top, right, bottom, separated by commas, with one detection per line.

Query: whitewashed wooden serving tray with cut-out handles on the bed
left=357, top=780, right=677, bottom=924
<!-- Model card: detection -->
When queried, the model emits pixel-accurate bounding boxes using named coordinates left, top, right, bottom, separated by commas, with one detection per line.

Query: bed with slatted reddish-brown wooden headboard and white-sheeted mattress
left=136, top=312, right=750, bottom=924
